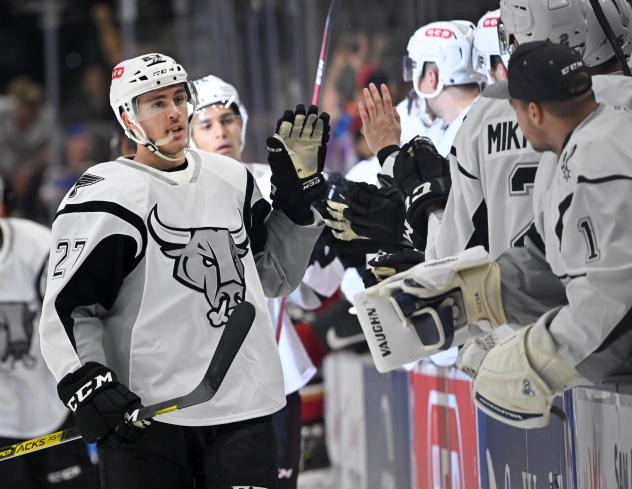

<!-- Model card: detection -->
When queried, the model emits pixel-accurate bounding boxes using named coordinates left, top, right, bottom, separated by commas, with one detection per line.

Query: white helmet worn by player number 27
left=110, top=53, right=197, bottom=161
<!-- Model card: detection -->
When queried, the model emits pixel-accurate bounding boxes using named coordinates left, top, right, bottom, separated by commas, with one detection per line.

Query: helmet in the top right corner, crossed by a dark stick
left=584, top=0, right=632, bottom=66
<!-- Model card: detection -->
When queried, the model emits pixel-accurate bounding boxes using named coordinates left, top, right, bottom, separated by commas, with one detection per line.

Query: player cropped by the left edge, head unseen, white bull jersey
left=0, top=180, right=99, bottom=489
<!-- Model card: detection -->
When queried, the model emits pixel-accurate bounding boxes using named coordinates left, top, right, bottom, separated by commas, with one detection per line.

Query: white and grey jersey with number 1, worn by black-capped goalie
left=533, top=105, right=632, bottom=380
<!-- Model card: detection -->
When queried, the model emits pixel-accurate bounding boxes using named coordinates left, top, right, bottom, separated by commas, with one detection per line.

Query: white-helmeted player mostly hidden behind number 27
left=191, top=75, right=342, bottom=489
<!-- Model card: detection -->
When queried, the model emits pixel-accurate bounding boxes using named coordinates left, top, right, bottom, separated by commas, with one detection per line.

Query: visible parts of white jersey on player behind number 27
left=245, top=163, right=316, bottom=395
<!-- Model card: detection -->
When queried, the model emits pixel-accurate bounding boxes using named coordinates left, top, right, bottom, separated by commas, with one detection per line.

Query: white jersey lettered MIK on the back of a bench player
left=426, top=75, right=632, bottom=259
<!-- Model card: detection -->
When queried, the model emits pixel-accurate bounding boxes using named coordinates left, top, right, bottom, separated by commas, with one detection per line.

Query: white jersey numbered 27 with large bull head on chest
left=40, top=150, right=323, bottom=426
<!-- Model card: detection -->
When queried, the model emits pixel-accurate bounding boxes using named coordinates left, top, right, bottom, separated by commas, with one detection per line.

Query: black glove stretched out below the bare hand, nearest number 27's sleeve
left=343, top=182, right=405, bottom=243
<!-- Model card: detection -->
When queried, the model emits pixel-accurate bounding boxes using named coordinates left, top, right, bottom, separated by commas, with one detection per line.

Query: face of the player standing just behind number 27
left=193, top=104, right=243, bottom=160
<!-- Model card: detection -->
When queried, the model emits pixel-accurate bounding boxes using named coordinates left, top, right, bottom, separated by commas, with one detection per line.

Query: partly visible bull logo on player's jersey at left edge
left=0, top=302, right=35, bottom=370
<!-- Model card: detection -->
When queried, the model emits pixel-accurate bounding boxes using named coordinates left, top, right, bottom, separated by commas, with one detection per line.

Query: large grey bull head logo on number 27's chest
left=147, top=206, right=248, bottom=328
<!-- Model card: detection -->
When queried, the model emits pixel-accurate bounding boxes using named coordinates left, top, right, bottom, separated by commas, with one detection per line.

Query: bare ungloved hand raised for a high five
left=358, top=83, right=402, bottom=154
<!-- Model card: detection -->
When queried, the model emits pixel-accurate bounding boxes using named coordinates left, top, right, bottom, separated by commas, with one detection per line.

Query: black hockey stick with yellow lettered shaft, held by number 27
left=0, top=302, right=255, bottom=462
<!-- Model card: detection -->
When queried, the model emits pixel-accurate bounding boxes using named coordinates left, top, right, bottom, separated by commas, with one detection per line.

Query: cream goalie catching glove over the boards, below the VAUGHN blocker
left=473, top=318, right=578, bottom=428
